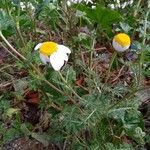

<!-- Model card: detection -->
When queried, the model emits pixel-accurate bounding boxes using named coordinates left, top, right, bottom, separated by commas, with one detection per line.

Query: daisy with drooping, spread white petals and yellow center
left=34, top=41, right=71, bottom=71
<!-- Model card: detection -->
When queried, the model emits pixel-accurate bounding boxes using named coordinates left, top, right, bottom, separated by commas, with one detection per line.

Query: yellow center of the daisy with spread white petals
left=40, top=42, right=58, bottom=56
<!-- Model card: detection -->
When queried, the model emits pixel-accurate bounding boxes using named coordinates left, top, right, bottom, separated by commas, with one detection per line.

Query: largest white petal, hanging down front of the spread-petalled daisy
left=50, top=52, right=65, bottom=71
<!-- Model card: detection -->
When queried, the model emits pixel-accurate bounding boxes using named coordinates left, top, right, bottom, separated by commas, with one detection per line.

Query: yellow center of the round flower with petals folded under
left=114, top=33, right=131, bottom=47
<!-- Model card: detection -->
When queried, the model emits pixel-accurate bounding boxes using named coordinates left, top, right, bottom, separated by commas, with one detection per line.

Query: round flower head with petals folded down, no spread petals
left=112, top=33, right=131, bottom=52
